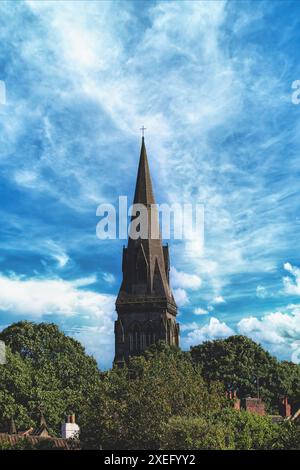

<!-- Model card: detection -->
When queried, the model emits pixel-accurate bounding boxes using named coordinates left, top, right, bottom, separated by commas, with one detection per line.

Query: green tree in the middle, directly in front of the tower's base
left=82, top=344, right=224, bottom=449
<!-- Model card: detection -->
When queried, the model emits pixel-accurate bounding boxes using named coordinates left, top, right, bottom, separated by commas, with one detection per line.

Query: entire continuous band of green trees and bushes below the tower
left=0, top=322, right=300, bottom=450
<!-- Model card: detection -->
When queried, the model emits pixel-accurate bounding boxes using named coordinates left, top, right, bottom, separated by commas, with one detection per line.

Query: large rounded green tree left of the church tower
left=0, top=322, right=100, bottom=435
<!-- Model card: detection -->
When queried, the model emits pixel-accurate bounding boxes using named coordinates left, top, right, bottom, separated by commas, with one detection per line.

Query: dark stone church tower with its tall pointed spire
left=114, top=137, right=179, bottom=365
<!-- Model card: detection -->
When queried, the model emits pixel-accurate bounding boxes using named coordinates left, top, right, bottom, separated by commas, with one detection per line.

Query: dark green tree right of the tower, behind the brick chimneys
left=191, top=336, right=300, bottom=412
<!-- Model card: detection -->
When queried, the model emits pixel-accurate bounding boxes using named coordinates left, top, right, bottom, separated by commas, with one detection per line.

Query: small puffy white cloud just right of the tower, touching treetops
left=183, top=317, right=235, bottom=347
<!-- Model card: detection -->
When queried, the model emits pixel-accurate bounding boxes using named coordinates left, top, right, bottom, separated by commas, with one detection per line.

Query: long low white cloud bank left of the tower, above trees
left=0, top=274, right=115, bottom=368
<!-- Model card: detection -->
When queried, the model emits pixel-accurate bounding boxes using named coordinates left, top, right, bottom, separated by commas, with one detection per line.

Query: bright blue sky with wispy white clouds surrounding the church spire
left=0, top=1, right=300, bottom=369
